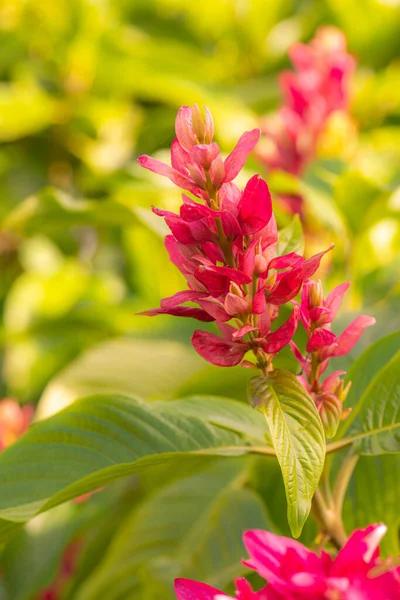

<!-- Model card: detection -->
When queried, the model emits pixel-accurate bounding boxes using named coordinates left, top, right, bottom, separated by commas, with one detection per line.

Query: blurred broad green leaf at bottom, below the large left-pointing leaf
left=78, top=460, right=269, bottom=600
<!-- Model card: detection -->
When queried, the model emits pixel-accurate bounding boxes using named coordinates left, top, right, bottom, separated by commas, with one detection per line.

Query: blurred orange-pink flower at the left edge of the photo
left=0, top=398, right=34, bottom=452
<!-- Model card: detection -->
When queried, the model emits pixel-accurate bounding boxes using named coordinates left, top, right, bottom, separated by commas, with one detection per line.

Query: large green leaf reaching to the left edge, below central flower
left=0, top=396, right=272, bottom=522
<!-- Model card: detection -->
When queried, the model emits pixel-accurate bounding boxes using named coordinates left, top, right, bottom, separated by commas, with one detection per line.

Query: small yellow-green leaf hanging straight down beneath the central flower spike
left=249, top=369, right=325, bottom=537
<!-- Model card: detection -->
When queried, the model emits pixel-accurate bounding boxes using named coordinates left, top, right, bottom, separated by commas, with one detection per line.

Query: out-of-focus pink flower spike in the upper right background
left=257, top=27, right=355, bottom=212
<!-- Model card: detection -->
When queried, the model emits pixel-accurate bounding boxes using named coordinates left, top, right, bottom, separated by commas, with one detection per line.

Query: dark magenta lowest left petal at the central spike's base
left=192, top=331, right=248, bottom=367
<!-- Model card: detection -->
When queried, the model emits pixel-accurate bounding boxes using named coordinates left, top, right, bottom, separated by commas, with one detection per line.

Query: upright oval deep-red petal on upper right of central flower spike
left=238, top=175, right=272, bottom=235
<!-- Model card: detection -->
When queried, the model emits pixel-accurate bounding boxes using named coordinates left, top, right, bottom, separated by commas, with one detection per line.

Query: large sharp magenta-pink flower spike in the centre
left=139, top=106, right=330, bottom=373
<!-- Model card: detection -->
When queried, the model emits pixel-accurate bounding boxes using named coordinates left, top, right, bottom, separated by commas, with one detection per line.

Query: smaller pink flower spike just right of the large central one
left=290, top=280, right=375, bottom=437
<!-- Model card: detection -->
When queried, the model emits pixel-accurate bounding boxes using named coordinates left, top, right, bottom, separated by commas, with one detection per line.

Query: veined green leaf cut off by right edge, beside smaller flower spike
left=349, top=351, right=400, bottom=455
